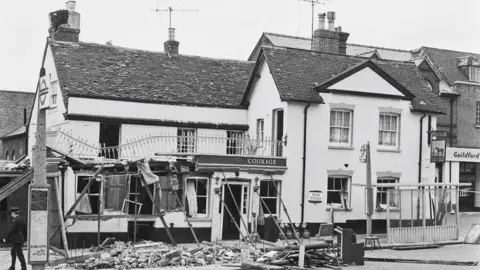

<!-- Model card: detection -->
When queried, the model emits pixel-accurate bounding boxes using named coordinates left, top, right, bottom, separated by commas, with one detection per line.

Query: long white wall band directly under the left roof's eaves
left=68, top=97, right=247, bottom=125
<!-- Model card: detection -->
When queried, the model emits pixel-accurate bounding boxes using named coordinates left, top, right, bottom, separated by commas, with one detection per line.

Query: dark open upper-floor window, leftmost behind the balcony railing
left=99, top=123, right=120, bottom=159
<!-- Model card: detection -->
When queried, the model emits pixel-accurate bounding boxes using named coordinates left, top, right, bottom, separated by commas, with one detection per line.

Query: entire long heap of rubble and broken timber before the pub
left=66, top=239, right=342, bottom=270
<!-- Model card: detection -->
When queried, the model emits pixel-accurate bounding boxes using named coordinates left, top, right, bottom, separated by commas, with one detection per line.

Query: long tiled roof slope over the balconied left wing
left=49, top=40, right=254, bottom=107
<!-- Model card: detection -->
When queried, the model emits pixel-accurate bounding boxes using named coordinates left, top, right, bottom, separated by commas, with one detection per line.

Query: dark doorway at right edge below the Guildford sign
left=459, top=162, right=475, bottom=212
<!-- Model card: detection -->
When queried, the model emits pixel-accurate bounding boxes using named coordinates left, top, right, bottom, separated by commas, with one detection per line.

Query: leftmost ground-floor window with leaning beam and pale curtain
left=75, top=175, right=101, bottom=214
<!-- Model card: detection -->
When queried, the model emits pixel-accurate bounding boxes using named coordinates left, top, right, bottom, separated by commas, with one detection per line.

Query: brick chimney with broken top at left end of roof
left=48, top=0, right=80, bottom=42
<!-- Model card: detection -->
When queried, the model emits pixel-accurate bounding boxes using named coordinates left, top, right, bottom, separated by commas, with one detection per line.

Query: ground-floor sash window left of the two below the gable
left=327, top=176, right=350, bottom=209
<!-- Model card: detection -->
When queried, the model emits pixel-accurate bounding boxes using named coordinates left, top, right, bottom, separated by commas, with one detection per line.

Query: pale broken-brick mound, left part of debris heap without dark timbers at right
left=76, top=241, right=251, bottom=269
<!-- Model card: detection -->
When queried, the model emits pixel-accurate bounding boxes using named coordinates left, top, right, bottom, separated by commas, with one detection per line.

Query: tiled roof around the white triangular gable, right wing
left=262, top=47, right=445, bottom=113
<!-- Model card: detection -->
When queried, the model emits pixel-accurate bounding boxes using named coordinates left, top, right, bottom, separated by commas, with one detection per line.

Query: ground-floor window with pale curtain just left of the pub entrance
left=185, top=177, right=210, bottom=217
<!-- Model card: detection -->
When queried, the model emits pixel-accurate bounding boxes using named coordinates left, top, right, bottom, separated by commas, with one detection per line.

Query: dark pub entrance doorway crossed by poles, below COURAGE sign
left=222, top=184, right=242, bottom=240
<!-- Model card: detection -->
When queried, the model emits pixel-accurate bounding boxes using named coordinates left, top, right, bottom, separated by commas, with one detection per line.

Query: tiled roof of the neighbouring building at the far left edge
left=0, top=90, right=35, bottom=137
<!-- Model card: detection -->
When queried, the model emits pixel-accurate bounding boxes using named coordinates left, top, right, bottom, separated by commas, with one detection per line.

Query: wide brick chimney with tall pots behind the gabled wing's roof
left=312, top=11, right=350, bottom=54
